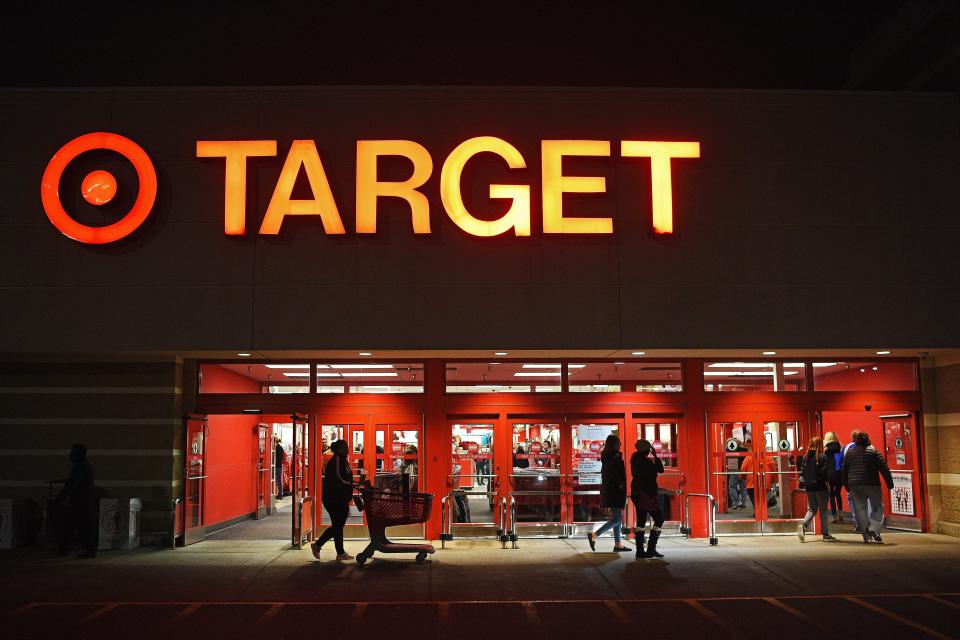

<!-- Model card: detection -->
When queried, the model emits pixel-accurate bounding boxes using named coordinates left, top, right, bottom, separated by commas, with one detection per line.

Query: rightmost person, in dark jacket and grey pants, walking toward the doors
left=843, top=433, right=893, bottom=542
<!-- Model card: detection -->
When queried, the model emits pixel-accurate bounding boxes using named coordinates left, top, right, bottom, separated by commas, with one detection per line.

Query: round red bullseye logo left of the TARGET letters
left=40, top=132, right=157, bottom=244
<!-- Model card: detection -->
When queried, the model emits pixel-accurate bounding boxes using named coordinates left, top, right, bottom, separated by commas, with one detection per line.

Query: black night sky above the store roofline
left=0, top=0, right=916, bottom=89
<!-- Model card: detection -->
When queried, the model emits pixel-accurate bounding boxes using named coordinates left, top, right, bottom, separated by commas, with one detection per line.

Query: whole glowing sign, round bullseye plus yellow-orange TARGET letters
left=40, top=132, right=700, bottom=244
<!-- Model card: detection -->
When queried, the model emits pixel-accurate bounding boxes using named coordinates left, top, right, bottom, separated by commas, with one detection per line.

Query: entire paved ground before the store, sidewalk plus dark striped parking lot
left=0, top=533, right=960, bottom=640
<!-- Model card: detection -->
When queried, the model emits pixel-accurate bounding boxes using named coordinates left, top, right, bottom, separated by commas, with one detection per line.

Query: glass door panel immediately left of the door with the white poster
left=510, top=421, right=569, bottom=536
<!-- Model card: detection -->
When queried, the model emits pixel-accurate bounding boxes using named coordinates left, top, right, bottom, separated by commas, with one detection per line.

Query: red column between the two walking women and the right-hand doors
left=683, top=358, right=709, bottom=538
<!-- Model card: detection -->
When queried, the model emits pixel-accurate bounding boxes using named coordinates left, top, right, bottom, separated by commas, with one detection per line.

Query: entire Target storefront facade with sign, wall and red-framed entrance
left=0, top=88, right=960, bottom=539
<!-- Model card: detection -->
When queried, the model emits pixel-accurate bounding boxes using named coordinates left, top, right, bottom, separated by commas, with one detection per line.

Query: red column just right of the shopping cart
left=423, top=359, right=450, bottom=540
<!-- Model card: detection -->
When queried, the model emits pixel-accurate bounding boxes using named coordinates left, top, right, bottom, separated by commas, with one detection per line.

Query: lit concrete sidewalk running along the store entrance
left=0, top=533, right=960, bottom=607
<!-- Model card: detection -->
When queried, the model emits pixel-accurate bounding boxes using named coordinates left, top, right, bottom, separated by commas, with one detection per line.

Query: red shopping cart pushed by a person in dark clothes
left=357, top=484, right=436, bottom=564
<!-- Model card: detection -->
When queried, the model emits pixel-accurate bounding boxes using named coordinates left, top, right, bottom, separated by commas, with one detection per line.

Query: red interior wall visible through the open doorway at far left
left=202, top=365, right=260, bottom=526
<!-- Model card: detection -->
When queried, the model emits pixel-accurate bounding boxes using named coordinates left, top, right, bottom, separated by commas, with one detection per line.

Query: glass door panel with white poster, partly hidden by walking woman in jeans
left=570, top=421, right=623, bottom=535
